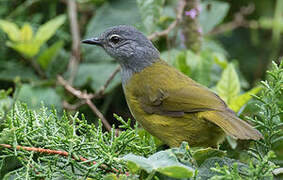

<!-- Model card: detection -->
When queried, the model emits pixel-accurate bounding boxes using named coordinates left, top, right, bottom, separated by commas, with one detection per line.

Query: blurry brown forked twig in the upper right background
left=209, top=4, right=255, bottom=35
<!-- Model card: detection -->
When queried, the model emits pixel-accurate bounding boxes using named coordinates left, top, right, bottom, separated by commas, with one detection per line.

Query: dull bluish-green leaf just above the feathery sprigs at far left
left=18, top=84, right=62, bottom=111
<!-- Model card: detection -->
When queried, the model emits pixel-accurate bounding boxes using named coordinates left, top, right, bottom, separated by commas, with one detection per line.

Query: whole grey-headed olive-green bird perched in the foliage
left=82, top=25, right=262, bottom=148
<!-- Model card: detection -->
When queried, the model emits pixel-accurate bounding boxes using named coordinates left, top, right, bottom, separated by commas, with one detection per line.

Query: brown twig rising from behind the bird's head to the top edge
left=148, top=0, right=186, bottom=40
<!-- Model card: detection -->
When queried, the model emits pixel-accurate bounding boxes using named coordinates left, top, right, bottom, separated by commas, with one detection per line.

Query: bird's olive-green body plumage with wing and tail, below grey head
left=125, top=60, right=260, bottom=147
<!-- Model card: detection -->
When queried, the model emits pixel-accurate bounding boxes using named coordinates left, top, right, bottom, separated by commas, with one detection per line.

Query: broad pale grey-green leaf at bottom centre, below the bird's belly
left=123, top=151, right=194, bottom=178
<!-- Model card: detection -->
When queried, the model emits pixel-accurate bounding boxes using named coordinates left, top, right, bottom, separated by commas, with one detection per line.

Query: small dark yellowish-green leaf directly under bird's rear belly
left=192, top=147, right=226, bottom=165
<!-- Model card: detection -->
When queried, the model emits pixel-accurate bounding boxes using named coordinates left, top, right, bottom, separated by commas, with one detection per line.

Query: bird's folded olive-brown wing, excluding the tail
left=140, top=83, right=227, bottom=116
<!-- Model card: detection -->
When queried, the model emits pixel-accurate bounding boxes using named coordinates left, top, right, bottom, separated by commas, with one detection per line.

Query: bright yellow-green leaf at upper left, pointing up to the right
left=34, top=15, right=66, bottom=46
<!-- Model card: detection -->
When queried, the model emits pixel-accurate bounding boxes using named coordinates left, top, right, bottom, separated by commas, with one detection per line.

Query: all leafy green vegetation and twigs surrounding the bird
left=0, top=0, right=283, bottom=179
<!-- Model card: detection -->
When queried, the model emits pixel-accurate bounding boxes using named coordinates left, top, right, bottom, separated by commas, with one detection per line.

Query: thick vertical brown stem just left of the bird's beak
left=67, top=0, right=81, bottom=84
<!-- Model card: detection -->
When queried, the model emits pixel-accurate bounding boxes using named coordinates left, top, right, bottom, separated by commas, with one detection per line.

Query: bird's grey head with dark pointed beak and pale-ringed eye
left=82, top=25, right=159, bottom=81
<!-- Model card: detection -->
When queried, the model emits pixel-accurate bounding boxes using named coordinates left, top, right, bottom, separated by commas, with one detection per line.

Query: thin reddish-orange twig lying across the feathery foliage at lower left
left=0, top=144, right=120, bottom=173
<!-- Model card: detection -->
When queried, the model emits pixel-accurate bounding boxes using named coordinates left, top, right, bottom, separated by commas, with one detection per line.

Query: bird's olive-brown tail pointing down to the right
left=200, top=111, right=262, bottom=140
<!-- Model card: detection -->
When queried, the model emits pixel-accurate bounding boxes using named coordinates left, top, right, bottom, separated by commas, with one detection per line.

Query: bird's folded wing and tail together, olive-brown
left=140, top=84, right=262, bottom=140
